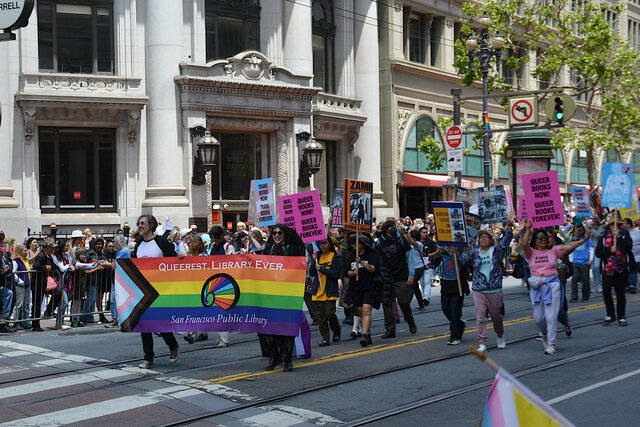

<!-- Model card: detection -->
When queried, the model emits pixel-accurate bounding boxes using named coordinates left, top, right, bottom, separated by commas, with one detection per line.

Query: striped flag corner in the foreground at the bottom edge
left=480, top=369, right=575, bottom=427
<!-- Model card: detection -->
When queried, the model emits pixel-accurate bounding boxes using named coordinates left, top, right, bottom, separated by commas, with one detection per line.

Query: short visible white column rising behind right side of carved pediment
left=282, top=0, right=313, bottom=76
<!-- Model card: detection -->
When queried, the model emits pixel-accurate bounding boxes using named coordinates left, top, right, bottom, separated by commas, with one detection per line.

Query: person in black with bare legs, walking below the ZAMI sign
left=339, top=235, right=380, bottom=347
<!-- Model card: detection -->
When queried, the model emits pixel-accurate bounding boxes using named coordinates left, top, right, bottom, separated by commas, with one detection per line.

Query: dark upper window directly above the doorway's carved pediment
left=205, top=0, right=260, bottom=62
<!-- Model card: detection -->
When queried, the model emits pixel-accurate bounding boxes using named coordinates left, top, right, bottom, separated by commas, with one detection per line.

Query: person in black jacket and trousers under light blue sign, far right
left=596, top=220, right=636, bottom=326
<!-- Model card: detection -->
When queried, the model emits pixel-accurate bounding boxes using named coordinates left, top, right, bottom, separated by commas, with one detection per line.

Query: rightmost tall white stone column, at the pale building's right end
left=353, top=0, right=390, bottom=211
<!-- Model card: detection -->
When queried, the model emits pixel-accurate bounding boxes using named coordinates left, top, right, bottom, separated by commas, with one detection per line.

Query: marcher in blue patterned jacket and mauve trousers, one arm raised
left=459, top=211, right=515, bottom=352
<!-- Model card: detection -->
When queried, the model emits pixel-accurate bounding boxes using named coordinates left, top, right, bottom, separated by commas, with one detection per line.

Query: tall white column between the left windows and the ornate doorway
left=142, top=0, right=189, bottom=207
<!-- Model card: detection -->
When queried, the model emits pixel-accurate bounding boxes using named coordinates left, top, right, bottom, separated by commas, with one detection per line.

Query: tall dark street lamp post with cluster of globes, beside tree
left=464, top=12, right=504, bottom=187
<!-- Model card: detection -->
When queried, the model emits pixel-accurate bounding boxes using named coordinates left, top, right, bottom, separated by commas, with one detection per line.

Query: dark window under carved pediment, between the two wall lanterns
left=212, top=133, right=269, bottom=200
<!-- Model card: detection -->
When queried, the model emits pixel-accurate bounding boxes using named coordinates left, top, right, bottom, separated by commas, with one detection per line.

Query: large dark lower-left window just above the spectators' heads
left=39, top=128, right=116, bottom=212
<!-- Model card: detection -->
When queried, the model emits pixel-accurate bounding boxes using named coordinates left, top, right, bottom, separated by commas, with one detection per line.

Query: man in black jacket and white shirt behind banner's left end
left=131, top=215, right=183, bottom=369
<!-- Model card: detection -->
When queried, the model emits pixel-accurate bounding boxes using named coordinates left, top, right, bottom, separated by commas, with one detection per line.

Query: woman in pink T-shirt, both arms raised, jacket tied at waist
left=522, top=219, right=591, bottom=354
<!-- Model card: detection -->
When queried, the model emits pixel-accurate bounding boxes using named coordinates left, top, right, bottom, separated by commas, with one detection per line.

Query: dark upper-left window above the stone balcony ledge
left=38, top=0, right=114, bottom=74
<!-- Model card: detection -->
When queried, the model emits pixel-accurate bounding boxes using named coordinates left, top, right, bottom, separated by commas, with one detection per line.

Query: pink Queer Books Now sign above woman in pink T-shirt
left=522, top=171, right=565, bottom=228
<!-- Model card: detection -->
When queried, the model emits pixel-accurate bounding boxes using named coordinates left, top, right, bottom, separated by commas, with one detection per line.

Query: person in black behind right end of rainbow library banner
left=262, top=224, right=305, bottom=372
